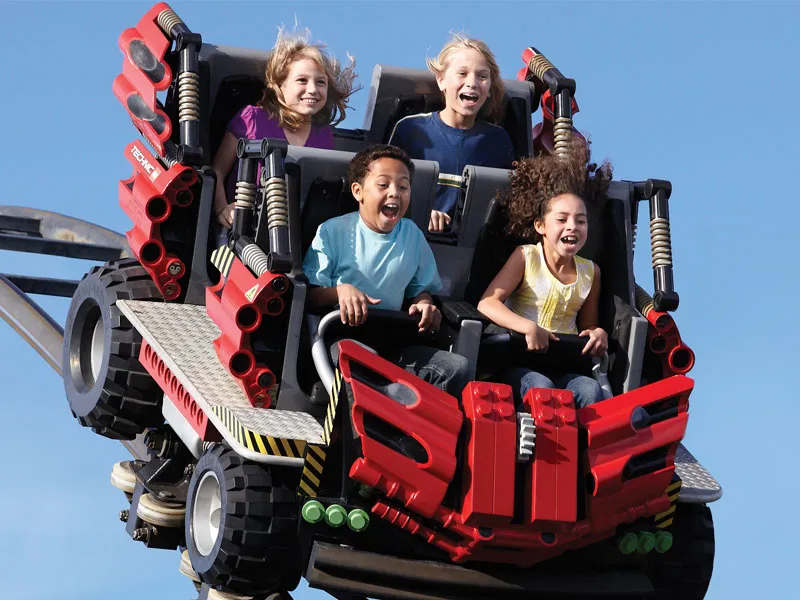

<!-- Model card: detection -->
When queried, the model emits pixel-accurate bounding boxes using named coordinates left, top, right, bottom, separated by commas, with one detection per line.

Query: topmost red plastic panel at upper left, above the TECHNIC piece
left=114, top=2, right=172, bottom=156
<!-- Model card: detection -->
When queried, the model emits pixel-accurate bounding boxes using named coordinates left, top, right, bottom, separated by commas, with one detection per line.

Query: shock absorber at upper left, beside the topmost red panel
left=156, top=8, right=203, bottom=165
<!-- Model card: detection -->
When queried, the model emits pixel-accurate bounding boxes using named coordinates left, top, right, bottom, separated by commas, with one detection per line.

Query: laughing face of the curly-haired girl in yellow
left=534, top=194, right=589, bottom=258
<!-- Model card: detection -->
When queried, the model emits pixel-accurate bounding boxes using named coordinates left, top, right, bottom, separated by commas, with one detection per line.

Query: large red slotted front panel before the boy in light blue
left=339, top=341, right=463, bottom=517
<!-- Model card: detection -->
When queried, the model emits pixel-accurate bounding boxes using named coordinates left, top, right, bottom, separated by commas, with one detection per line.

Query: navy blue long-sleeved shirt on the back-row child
left=389, top=113, right=514, bottom=216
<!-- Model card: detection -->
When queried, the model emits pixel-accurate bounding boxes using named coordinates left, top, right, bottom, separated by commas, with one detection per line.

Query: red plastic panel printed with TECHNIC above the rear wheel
left=119, top=142, right=197, bottom=300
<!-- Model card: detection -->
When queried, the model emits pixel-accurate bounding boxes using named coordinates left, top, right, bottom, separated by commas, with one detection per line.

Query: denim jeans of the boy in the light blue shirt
left=331, top=340, right=468, bottom=400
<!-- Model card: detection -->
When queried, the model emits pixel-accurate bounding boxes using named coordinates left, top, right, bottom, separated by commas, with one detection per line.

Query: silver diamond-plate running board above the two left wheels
left=117, top=300, right=323, bottom=444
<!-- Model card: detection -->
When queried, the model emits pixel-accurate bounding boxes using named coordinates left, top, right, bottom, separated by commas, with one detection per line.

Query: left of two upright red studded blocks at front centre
left=461, top=381, right=517, bottom=526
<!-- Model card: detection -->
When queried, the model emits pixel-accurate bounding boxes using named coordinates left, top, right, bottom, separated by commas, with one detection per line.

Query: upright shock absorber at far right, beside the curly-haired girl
left=644, top=179, right=679, bottom=312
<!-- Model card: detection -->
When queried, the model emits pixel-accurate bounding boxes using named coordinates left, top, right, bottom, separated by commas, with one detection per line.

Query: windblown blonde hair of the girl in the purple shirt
left=259, top=30, right=356, bottom=130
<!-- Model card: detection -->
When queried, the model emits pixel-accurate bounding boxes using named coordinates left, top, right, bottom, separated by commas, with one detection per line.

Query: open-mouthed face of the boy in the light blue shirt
left=350, top=158, right=411, bottom=233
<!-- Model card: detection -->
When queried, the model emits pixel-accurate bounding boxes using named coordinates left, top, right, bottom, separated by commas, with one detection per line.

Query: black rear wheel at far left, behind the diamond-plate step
left=62, top=259, right=164, bottom=440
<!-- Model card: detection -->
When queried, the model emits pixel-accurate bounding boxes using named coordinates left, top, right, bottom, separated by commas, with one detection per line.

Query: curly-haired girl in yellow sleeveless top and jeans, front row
left=478, top=156, right=608, bottom=407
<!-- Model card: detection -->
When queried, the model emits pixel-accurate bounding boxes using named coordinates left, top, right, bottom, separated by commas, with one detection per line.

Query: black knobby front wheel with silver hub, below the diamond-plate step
left=186, top=444, right=301, bottom=595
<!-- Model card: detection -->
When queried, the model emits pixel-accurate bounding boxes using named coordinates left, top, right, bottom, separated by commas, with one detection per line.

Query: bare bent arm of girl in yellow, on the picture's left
left=478, top=246, right=558, bottom=350
